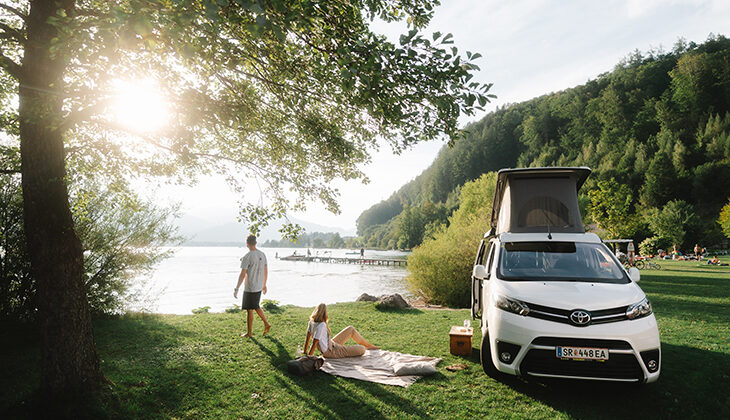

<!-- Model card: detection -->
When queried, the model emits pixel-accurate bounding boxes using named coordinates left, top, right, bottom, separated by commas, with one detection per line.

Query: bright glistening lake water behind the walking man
left=134, top=247, right=409, bottom=314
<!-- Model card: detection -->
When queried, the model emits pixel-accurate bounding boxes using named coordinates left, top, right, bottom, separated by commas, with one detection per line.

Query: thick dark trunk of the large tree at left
left=19, top=0, right=102, bottom=398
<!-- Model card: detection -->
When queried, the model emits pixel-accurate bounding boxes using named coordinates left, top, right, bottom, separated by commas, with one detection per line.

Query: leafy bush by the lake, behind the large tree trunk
left=0, top=172, right=181, bottom=321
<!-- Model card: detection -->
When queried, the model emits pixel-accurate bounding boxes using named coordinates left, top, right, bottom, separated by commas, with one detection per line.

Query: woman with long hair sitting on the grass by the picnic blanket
left=304, top=303, right=380, bottom=359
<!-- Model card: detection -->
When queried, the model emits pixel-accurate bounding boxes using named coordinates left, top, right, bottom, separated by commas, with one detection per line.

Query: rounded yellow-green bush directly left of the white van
left=407, top=172, right=497, bottom=307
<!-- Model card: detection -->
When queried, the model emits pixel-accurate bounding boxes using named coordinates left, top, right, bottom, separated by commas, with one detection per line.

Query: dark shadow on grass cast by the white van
left=500, top=344, right=730, bottom=419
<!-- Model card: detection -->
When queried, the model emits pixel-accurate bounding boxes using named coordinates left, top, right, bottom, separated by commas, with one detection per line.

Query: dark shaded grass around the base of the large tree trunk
left=0, top=315, right=209, bottom=418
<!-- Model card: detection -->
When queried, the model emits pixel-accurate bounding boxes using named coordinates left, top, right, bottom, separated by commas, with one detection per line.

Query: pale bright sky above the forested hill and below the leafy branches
left=158, top=0, right=730, bottom=233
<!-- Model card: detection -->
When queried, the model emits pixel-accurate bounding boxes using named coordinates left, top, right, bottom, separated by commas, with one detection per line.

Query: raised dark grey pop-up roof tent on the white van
left=492, top=167, right=591, bottom=234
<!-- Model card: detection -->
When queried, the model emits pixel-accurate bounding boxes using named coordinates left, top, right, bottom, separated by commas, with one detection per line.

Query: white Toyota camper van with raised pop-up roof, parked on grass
left=472, top=167, right=661, bottom=383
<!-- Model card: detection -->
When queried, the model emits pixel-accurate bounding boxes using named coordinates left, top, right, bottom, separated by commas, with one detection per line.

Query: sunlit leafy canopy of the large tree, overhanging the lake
left=0, top=0, right=489, bottom=230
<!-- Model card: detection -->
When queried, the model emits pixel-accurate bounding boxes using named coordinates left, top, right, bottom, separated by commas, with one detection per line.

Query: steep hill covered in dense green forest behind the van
left=357, top=36, right=730, bottom=248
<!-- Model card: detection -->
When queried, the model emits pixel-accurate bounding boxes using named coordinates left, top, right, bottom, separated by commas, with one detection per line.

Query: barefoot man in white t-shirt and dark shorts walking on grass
left=233, top=235, right=271, bottom=338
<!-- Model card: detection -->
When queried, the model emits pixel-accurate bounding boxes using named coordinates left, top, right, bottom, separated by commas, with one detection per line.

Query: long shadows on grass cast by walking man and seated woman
left=251, top=337, right=431, bottom=419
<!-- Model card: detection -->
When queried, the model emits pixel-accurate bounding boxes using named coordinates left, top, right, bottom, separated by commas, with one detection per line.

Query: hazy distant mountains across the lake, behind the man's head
left=176, top=215, right=355, bottom=246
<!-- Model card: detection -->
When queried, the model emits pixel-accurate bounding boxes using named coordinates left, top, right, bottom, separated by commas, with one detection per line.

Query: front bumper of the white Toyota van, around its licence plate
left=483, top=308, right=661, bottom=382
